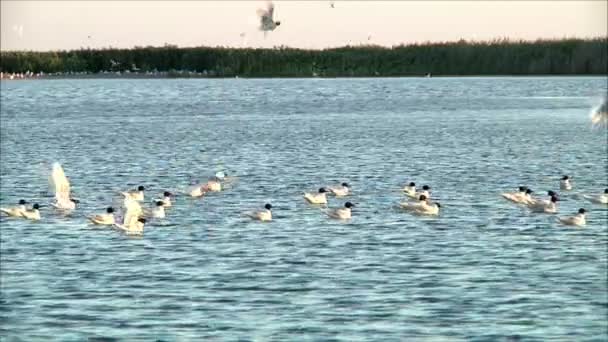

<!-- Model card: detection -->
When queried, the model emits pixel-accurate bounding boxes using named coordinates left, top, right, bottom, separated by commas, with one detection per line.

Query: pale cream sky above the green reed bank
left=0, top=0, right=608, bottom=50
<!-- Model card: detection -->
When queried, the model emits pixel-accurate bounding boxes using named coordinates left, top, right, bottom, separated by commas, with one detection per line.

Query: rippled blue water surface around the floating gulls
left=0, top=77, right=608, bottom=341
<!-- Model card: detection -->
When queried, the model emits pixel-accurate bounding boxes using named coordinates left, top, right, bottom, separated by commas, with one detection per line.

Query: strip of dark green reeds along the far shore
left=0, top=38, right=608, bottom=77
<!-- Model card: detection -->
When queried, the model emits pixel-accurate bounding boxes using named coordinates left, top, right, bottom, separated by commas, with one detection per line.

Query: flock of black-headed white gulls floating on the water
left=0, top=163, right=608, bottom=235
